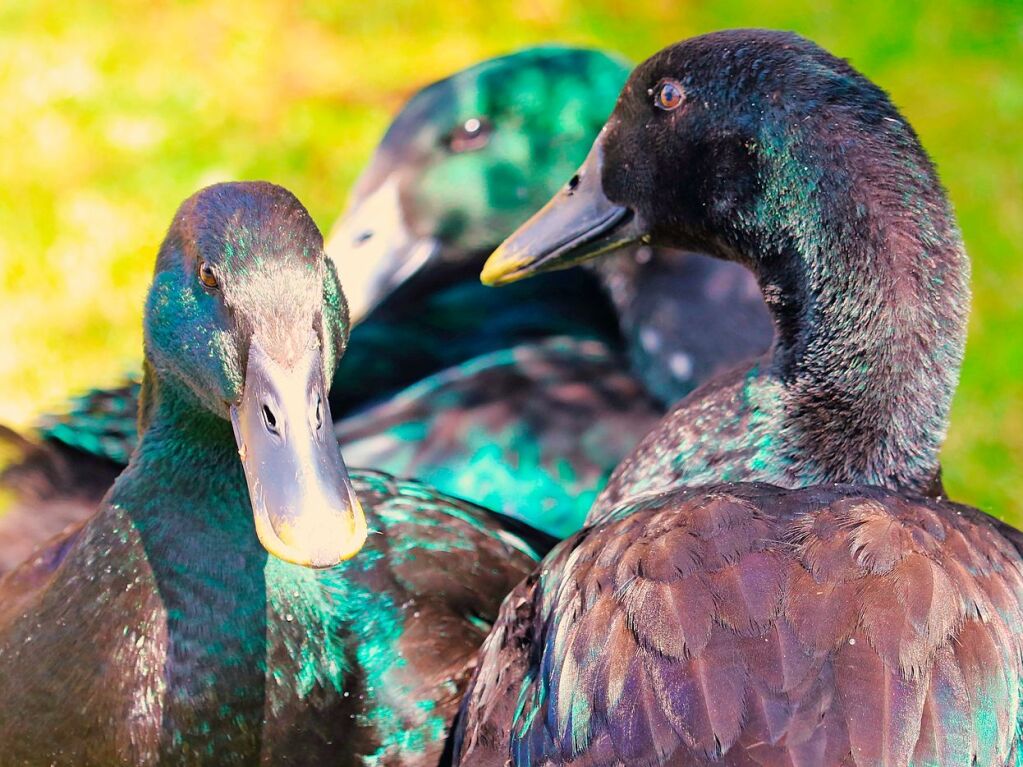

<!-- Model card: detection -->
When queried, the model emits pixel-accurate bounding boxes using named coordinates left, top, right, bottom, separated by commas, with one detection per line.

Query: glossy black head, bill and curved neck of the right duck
left=482, top=30, right=970, bottom=492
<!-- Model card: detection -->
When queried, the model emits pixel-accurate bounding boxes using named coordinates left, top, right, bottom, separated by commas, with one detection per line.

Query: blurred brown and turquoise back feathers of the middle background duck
left=336, top=336, right=660, bottom=538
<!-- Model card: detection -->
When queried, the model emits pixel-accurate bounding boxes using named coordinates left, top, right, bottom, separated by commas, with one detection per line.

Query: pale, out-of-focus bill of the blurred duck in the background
left=324, top=176, right=440, bottom=322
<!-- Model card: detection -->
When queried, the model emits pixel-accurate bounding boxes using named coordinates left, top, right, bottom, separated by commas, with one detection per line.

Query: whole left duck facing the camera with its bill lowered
left=0, top=182, right=552, bottom=765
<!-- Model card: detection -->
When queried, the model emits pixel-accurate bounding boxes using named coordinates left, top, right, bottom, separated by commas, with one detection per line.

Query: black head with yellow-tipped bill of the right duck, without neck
left=482, top=30, right=942, bottom=285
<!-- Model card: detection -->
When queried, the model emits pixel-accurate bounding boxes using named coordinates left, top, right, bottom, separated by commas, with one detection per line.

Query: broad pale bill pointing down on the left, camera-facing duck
left=230, top=335, right=366, bottom=568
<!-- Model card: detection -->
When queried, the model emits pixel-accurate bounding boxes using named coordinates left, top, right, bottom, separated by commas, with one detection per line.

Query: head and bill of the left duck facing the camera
left=145, top=183, right=366, bottom=568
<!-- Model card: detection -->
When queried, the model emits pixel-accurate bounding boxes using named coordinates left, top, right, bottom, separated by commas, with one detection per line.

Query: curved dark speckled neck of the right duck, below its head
left=739, top=118, right=969, bottom=492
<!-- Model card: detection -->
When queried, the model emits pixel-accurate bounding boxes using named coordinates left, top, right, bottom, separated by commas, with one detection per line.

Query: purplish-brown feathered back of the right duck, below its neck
left=461, top=485, right=1023, bottom=767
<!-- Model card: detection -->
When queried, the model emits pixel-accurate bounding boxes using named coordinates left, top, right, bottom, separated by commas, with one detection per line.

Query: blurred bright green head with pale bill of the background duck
left=326, top=47, right=629, bottom=319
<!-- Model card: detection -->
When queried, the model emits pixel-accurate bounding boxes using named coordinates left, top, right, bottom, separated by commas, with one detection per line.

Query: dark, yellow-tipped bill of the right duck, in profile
left=480, top=139, right=644, bottom=285
